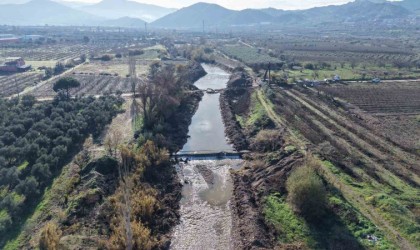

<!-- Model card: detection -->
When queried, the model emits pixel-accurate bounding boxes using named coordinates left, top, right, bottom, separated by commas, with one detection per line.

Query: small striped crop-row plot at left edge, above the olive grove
left=0, top=72, right=43, bottom=97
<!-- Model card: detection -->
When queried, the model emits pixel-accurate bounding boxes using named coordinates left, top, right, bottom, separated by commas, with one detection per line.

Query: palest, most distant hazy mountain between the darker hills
left=80, top=0, right=175, bottom=22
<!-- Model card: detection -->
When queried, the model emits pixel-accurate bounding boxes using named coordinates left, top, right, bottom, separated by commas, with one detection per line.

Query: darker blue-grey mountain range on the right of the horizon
left=152, top=0, right=420, bottom=29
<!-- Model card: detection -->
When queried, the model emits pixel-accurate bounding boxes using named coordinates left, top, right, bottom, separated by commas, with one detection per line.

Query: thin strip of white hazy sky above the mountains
left=65, top=0, right=353, bottom=9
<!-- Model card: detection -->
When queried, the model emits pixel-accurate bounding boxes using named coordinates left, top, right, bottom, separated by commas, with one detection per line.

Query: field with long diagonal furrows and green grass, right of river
left=254, top=83, right=420, bottom=247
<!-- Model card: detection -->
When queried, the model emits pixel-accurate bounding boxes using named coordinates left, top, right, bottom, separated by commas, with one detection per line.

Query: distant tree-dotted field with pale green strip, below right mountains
left=249, top=36, right=420, bottom=82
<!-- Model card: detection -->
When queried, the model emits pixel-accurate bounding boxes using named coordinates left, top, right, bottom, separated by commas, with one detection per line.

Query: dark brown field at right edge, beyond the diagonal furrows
left=319, top=82, right=420, bottom=152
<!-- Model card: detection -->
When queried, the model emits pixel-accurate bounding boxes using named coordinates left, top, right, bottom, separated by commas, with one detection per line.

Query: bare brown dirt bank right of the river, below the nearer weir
left=231, top=149, right=303, bottom=249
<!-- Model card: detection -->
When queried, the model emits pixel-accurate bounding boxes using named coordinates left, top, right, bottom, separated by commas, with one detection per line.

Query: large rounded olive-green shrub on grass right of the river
left=286, top=162, right=326, bottom=221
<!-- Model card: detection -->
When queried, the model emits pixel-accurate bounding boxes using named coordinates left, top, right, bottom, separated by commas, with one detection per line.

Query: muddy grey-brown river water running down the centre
left=171, top=65, right=242, bottom=250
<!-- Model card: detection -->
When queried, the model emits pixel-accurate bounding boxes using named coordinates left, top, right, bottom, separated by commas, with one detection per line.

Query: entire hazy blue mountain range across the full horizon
left=0, top=0, right=420, bottom=29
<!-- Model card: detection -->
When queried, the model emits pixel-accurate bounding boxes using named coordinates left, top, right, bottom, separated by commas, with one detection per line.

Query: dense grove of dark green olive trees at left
left=0, top=93, right=123, bottom=236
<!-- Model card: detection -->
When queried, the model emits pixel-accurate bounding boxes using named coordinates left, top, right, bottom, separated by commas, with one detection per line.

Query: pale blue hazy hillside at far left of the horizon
left=0, top=0, right=103, bottom=25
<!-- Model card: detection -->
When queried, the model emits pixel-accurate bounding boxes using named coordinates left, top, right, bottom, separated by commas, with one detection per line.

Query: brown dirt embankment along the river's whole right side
left=220, top=72, right=303, bottom=249
